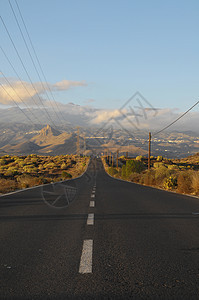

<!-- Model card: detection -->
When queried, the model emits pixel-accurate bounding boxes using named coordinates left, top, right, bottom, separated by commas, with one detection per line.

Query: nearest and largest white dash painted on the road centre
left=79, top=240, right=93, bottom=274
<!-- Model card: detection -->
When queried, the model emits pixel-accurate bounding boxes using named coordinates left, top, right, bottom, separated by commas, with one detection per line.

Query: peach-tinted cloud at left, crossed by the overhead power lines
left=0, top=78, right=87, bottom=105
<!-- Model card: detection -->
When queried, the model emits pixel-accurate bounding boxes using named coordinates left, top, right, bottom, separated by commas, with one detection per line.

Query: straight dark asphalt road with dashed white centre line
left=0, top=160, right=199, bottom=299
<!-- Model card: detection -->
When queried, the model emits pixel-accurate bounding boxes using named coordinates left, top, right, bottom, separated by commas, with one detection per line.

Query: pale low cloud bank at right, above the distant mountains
left=90, top=108, right=199, bottom=132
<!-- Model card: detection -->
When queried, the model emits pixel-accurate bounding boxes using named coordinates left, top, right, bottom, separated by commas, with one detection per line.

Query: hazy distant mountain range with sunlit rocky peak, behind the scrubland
left=0, top=123, right=199, bottom=158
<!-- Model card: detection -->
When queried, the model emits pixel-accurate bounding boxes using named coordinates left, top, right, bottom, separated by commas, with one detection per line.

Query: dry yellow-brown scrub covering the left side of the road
left=0, top=154, right=89, bottom=193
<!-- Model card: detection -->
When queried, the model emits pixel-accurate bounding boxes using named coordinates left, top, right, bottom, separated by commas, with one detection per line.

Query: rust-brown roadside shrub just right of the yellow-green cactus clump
left=177, top=171, right=192, bottom=194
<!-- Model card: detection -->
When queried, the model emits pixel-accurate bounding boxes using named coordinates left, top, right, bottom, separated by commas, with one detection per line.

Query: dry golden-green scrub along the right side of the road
left=102, top=154, right=199, bottom=196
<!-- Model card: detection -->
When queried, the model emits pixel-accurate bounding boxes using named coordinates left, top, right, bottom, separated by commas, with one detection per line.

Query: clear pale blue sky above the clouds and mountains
left=0, top=0, right=199, bottom=111
